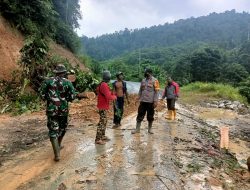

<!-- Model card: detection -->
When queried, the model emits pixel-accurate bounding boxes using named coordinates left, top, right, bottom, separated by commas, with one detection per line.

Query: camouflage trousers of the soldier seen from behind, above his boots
left=47, top=116, right=68, bottom=138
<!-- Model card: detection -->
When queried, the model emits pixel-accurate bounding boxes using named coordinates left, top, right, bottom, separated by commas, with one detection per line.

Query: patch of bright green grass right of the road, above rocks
left=180, top=82, right=247, bottom=104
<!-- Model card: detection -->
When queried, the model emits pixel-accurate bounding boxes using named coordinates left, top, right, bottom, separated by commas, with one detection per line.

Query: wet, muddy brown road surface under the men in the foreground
left=0, top=115, right=181, bottom=190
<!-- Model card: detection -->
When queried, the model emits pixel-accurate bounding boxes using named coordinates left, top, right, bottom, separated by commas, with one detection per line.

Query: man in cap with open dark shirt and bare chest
left=112, top=72, right=129, bottom=128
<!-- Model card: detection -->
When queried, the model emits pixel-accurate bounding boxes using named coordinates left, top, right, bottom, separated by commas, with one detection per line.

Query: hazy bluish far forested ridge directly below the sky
left=82, top=10, right=250, bottom=60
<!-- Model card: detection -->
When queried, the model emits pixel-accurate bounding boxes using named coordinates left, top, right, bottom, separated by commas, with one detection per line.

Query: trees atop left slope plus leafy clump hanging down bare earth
left=0, top=0, right=81, bottom=90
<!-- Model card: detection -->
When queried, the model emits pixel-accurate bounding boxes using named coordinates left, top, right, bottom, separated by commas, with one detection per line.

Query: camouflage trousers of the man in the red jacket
left=95, top=110, right=108, bottom=141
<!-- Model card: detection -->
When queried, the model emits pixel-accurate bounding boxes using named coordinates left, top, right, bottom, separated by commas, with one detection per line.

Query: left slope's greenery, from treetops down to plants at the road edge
left=0, top=0, right=88, bottom=114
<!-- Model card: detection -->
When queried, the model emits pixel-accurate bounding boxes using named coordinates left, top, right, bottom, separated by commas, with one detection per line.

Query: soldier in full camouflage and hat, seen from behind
left=41, top=64, right=75, bottom=161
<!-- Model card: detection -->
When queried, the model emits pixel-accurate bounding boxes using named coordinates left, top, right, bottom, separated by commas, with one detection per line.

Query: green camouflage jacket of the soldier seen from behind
left=40, top=76, right=76, bottom=116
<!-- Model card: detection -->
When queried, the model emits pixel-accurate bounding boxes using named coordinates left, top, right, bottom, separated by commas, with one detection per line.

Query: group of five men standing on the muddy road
left=41, top=64, right=179, bottom=161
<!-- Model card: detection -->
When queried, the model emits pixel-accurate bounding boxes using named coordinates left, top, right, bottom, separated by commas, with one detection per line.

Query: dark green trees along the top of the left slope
left=0, top=0, right=81, bottom=52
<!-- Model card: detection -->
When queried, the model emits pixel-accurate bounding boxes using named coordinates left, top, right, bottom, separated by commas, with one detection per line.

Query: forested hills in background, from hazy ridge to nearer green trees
left=81, top=10, right=250, bottom=102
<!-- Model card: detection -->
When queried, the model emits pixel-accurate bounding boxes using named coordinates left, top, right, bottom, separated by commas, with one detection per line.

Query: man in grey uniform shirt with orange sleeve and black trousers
left=132, top=68, right=160, bottom=134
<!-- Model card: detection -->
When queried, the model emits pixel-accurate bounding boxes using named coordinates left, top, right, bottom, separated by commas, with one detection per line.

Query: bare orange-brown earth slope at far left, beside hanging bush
left=0, top=17, right=23, bottom=80
